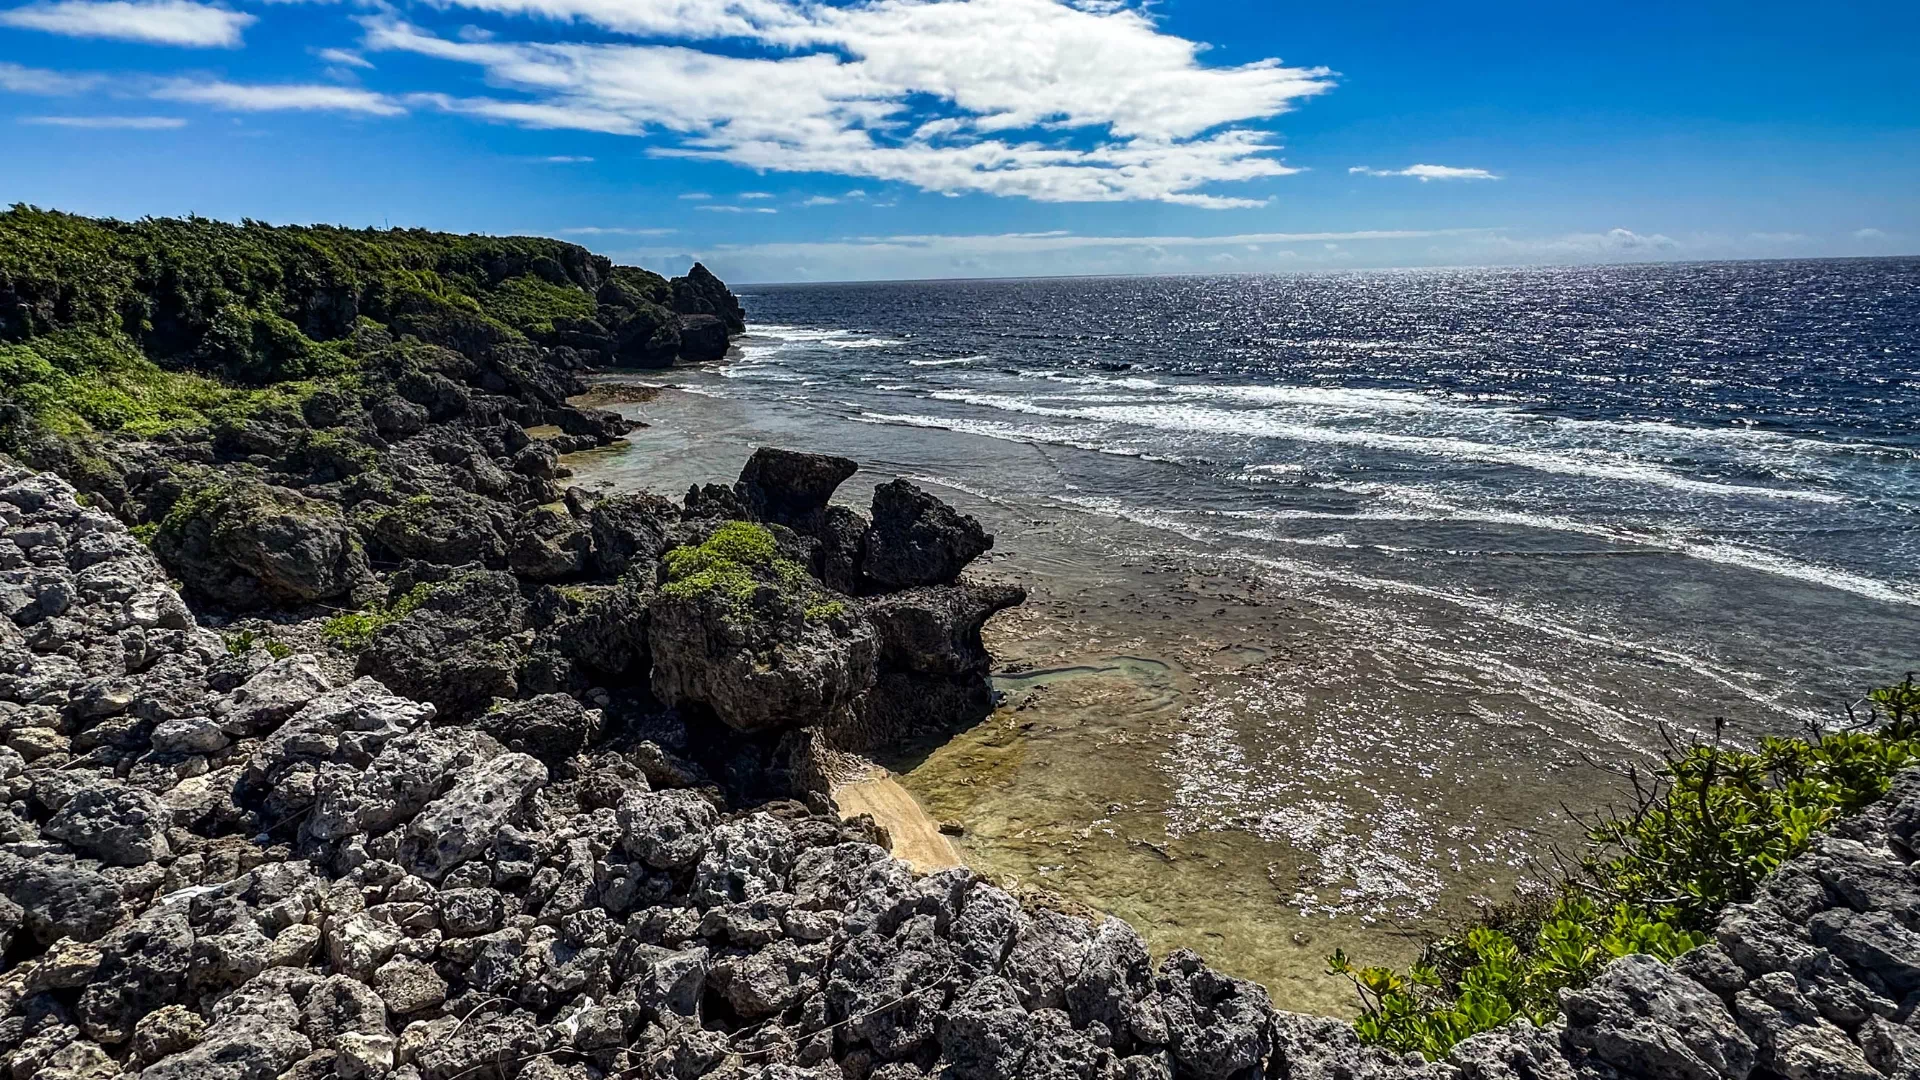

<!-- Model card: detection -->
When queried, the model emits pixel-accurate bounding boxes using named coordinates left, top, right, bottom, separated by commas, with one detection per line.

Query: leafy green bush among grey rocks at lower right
left=1329, top=675, right=1920, bottom=1057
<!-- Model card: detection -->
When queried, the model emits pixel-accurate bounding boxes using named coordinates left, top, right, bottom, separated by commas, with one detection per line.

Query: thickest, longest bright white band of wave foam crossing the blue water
left=929, top=390, right=1847, bottom=503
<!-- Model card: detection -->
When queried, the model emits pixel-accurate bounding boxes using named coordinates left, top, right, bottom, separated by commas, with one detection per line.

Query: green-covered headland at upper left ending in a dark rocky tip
left=0, top=206, right=741, bottom=473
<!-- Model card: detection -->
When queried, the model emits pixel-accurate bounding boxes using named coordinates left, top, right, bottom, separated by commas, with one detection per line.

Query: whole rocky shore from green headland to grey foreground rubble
left=0, top=209, right=1920, bottom=1080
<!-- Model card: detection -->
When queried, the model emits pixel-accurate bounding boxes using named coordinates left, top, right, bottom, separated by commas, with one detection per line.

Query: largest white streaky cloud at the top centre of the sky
left=349, top=0, right=1332, bottom=208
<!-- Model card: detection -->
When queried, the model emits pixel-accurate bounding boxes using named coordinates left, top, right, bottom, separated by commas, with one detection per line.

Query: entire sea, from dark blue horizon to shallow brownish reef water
left=576, top=259, right=1920, bottom=1009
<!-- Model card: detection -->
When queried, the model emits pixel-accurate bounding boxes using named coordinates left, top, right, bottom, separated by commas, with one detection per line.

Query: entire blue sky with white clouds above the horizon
left=0, top=0, right=1920, bottom=282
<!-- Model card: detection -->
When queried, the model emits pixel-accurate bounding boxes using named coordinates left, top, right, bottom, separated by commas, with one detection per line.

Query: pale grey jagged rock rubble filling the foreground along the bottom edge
left=0, top=451, right=1920, bottom=1080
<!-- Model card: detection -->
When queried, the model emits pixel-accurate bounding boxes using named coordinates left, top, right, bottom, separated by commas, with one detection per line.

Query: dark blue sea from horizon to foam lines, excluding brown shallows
left=730, top=259, right=1920, bottom=603
